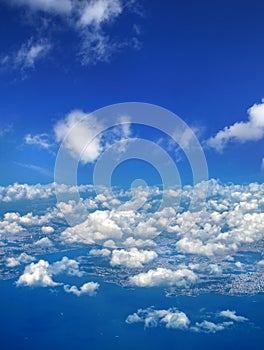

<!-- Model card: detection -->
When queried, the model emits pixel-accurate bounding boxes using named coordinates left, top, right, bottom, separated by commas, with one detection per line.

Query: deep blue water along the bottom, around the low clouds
left=0, top=277, right=264, bottom=350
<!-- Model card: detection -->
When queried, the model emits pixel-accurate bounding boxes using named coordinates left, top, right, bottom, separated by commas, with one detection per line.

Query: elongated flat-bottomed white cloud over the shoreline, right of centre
left=129, top=267, right=197, bottom=288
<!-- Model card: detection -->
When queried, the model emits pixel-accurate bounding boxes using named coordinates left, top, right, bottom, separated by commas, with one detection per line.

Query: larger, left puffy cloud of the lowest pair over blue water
left=126, top=307, right=190, bottom=329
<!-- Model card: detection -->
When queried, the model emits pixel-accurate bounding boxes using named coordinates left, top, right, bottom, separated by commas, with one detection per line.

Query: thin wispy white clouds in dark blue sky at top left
left=0, top=0, right=140, bottom=72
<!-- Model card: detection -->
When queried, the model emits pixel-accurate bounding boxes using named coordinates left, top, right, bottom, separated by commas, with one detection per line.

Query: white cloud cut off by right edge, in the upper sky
left=207, top=101, right=264, bottom=152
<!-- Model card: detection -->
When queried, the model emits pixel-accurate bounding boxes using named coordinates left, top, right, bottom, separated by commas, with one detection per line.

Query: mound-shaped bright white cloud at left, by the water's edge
left=16, top=259, right=59, bottom=287
